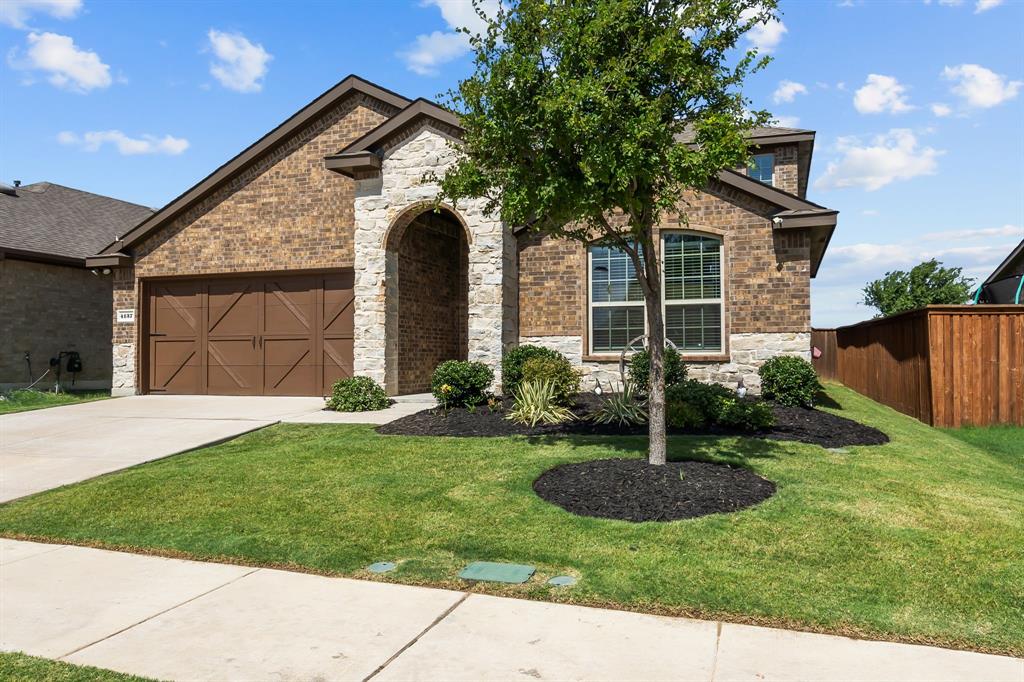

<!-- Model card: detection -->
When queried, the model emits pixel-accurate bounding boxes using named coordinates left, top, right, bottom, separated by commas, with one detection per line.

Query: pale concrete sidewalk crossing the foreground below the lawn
left=0, top=540, right=1024, bottom=682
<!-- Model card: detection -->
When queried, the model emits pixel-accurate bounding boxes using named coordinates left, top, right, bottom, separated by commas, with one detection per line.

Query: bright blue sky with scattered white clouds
left=0, top=0, right=1024, bottom=327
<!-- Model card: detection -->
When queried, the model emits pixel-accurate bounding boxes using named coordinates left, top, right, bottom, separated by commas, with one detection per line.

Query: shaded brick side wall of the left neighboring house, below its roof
left=0, top=257, right=112, bottom=388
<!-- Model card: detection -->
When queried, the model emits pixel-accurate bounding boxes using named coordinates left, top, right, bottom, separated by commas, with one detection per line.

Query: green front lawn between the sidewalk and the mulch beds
left=0, top=386, right=1024, bottom=655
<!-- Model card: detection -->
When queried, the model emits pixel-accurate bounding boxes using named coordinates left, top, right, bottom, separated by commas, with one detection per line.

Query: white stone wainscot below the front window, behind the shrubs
left=519, top=332, right=811, bottom=393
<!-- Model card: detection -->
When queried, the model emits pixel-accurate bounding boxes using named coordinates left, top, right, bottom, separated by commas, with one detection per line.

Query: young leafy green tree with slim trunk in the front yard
left=432, top=0, right=775, bottom=464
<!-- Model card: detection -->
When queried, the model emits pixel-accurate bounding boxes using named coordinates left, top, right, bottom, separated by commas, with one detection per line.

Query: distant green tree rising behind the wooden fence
left=864, top=258, right=974, bottom=317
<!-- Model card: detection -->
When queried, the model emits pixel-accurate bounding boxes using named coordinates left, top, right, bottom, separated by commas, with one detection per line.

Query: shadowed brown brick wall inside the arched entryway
left=398, top=214, right=467, bottom=394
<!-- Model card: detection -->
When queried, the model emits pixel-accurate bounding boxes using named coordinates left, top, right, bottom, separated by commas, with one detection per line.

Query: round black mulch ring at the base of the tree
left=534, top=459, right=775, bottom=521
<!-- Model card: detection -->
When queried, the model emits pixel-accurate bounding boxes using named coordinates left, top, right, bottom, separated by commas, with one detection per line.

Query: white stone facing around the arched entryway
left=353, top=125, right=515, bottom=393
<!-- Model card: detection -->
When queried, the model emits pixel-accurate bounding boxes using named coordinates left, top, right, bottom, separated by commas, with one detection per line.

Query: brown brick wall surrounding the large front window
left=519, top=175, right=811, bottom=350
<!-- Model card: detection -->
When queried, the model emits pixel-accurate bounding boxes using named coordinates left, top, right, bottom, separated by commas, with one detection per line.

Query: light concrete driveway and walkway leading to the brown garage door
left=0, top=395, right=387, bottom=502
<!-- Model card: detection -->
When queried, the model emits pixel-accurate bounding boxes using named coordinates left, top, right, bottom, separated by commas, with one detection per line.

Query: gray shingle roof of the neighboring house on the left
left=0, top=182, right=153, bottom=265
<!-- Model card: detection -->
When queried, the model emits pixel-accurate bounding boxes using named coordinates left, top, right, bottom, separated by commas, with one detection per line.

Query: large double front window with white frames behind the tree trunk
left=588, top=232, right=724, bottom=355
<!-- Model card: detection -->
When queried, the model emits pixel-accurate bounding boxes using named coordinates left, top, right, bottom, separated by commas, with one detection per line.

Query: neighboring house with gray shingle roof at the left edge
left=0, top=182, right=153, bottom=390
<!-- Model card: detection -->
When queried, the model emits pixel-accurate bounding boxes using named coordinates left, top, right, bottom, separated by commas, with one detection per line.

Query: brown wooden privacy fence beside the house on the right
left=811, top=305, right=1024, bottom=426
